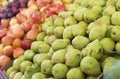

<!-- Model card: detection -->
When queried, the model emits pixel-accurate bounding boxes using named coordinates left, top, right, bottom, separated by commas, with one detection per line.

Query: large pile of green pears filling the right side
left=7, top=0, right=120, bottom=79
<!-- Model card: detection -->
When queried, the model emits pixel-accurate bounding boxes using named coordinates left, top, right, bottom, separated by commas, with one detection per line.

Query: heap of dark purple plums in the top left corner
left=0, top=0, right=28, bottom=20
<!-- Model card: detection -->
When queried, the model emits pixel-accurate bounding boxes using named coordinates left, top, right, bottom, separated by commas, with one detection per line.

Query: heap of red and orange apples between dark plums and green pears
left=0, top=0, right=65, bottom=67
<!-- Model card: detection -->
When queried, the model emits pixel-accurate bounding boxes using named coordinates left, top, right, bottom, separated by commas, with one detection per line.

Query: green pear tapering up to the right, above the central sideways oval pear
left=72, top=21, right=87, bottom=36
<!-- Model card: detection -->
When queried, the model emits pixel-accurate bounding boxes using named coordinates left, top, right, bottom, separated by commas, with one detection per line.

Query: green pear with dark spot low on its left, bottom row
left=41, top=60, right=53, bottom=75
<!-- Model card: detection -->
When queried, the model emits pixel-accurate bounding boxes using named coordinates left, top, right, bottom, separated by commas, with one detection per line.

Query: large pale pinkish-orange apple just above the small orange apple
left=12, top=27, right=24, bottom=38
